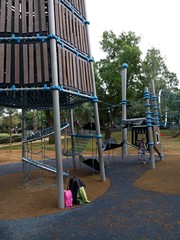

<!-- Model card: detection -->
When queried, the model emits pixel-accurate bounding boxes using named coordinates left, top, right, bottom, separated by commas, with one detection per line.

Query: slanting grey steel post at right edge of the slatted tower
left=85, top=0, right=106, bottom=182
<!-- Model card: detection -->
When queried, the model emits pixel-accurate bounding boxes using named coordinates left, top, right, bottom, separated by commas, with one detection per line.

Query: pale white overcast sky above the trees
left=86, top=0, right=180, bottom=80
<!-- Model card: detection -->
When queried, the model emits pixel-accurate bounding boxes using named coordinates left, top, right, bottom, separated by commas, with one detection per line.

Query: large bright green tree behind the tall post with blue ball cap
left=94, top=31, right=142, bottom=125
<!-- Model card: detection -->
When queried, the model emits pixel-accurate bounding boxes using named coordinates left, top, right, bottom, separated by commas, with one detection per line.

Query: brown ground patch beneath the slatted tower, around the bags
left=0, top=170, right=110, bottom=220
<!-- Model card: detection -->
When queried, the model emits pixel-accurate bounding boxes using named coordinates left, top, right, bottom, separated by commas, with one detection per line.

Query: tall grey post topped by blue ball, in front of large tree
left=121, top=63, right=128, bottom=161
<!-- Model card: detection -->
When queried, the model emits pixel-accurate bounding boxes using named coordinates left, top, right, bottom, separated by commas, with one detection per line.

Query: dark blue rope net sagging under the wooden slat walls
left=0, top=85, right=94, bottom=110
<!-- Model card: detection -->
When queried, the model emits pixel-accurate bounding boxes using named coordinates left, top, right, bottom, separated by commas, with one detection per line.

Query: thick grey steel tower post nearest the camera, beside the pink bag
left=48, top=0, right=64, bottom=208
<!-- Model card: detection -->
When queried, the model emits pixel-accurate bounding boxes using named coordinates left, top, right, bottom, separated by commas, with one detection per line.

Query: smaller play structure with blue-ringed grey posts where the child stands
left=121, top=64, right=163, bottom=169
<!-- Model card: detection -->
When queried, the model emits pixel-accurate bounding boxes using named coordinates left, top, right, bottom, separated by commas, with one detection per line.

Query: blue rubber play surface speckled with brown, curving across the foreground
left=0, top=157, right=180, bottom=240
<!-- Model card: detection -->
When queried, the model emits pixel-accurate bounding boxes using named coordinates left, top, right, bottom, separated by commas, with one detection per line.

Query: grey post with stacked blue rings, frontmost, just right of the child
left=144, top=87, right=156, bottom=169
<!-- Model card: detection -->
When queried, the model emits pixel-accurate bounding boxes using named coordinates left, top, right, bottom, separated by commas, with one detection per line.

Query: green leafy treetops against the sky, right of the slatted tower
left=94, top=31, right=178, bottom=125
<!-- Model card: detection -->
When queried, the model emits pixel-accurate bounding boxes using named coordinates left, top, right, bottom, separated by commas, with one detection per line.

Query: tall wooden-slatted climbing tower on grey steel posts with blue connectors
left=0, top=0, right=106, bottom=208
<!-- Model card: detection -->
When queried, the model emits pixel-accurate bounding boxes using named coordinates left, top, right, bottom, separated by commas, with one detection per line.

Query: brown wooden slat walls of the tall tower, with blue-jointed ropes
left=0, top=0, right=93, bottom=93
